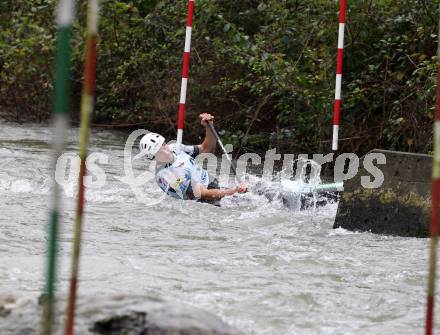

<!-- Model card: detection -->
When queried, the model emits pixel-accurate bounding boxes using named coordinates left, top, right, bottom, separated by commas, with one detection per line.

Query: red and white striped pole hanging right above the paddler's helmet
left=177, top=0, right=194, bottom=152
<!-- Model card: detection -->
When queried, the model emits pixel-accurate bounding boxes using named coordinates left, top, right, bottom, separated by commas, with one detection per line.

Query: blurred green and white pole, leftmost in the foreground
left=42, top=0, right=75, bottom=335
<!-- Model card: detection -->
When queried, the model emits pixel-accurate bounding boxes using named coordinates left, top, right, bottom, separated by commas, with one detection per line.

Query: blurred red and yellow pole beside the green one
left=65, top=0, right=98, bottom=335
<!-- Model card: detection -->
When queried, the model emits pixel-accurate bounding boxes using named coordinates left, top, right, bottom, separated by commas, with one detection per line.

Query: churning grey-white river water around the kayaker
left=0, top=123, right=439, bottom=335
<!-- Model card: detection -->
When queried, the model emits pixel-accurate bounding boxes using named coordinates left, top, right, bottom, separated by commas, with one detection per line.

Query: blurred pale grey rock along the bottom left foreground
left=0, top=295, right=241, bottom=335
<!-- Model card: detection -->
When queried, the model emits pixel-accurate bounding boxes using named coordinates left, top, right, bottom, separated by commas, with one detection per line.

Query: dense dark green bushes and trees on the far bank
left=0, top=0, right=439, bottom=152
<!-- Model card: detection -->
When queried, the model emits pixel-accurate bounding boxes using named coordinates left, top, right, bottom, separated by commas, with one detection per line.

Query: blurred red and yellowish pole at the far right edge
left=425, top=6, right=440, bottom=335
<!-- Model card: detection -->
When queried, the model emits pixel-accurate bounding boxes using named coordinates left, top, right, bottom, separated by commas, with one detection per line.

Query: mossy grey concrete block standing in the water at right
left=333, top=149, right=432, bottom=237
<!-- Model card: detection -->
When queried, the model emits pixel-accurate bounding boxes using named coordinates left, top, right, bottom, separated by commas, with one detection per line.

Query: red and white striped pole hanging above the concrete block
left=332, top=0, right=347, bottom=151
